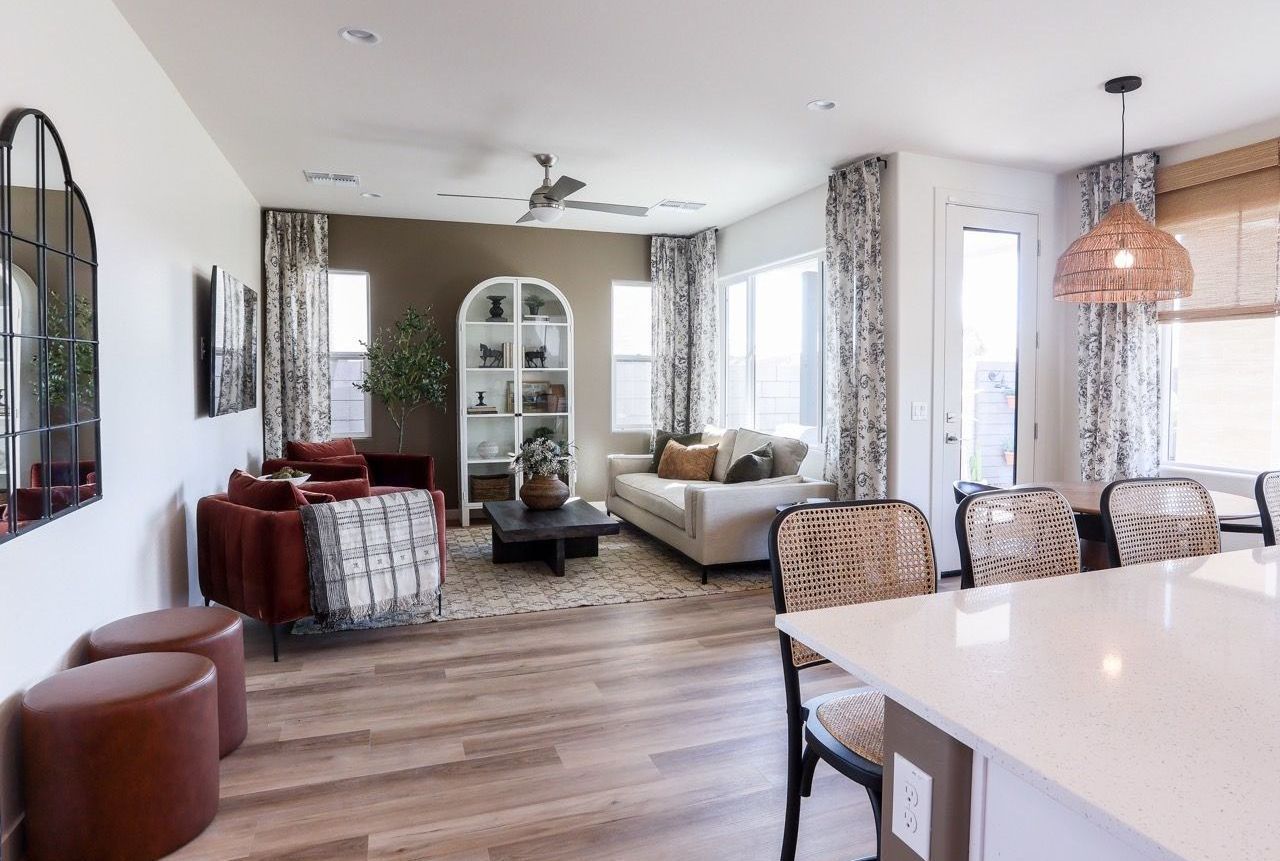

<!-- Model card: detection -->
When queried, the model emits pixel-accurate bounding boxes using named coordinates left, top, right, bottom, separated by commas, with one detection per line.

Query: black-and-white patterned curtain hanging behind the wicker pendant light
left=1075, top=152, right=1160, bottom=481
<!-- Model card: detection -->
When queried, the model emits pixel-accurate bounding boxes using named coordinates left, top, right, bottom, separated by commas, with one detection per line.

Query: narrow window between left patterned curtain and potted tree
left=329, top=270, right=372, bottom=436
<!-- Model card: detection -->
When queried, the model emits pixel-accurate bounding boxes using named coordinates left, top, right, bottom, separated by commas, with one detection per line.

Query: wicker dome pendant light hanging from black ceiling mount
left=1053, top=75, right=1193, bottom=302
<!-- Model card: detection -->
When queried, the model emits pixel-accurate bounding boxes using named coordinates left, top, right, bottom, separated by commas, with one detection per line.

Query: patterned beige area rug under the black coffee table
left=293, top=523, right=769, bottom=633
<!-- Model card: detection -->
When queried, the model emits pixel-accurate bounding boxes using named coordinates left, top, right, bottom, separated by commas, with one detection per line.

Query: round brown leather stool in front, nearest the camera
left=22, top=652, right=218, bottom=861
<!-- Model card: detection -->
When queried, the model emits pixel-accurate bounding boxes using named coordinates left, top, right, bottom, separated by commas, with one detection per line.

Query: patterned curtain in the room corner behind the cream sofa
left=649, top=228, right=719, bottom=434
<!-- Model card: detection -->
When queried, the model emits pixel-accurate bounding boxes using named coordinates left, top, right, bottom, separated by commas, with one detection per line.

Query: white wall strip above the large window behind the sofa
left=716, top=183, right=827, bottom=276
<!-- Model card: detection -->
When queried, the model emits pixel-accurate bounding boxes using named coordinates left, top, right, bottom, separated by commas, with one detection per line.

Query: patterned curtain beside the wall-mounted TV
left=262, top=211, right=329, bottom=458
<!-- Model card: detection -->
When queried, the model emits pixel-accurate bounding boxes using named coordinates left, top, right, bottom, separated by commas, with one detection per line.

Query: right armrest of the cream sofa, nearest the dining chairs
left=685, top=481, right=836, bottom=541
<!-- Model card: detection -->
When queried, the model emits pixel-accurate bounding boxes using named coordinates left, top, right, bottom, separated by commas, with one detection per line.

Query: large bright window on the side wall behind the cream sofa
left=721, top=257, right=822, bottom=435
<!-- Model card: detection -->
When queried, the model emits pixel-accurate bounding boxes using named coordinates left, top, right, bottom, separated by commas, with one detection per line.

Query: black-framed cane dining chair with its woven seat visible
left=769, top=499, right=938, bottom=861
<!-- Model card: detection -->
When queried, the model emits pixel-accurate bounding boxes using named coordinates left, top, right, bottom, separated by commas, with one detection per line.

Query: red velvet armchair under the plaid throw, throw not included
left=196, top=475, right=445, bottom=660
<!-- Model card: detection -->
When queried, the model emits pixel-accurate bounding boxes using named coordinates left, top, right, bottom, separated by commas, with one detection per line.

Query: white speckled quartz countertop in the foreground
left=777, top=548, right=1280, bottom=861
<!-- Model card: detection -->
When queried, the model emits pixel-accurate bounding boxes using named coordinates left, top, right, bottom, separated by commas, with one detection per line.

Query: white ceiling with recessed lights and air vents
left=116, top=0, right=1280, bottom=233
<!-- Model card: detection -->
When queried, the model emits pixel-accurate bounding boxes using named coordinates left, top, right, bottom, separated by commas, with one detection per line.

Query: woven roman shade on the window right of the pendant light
left=1156, top=141, right=1280, bottom=321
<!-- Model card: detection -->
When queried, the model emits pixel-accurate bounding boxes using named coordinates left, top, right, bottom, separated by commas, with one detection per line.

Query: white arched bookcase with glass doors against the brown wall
left=457, top=276, right=575, bottom=526
